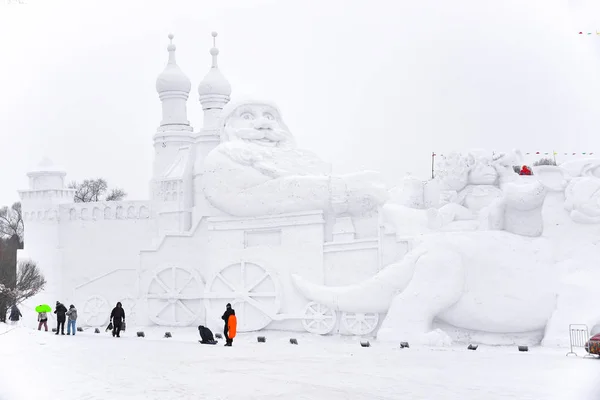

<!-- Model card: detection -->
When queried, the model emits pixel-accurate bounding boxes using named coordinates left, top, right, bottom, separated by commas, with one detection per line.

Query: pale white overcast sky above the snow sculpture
left=0, top=0, right=600, bottom=205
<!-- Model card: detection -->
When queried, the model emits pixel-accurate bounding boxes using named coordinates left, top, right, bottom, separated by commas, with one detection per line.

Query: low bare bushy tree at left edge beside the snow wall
left=0, top=260, right=46, bottom=322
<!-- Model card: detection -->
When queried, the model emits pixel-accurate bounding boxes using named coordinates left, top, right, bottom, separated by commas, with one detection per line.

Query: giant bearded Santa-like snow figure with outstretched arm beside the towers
left=202, top=102, right=387, bottom=216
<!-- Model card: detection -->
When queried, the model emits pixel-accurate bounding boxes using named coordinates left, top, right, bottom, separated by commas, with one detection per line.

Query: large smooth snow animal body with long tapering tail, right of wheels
left=294, top=231, right=558, bottom=343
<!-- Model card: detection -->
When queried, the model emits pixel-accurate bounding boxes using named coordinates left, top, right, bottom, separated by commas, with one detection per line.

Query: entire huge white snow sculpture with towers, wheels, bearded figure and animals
left=20, top=33, right=600, bottom=344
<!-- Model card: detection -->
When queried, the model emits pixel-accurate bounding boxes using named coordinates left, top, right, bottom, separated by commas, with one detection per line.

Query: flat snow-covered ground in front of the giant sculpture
left=0, top=324, right=600, bottom=400
